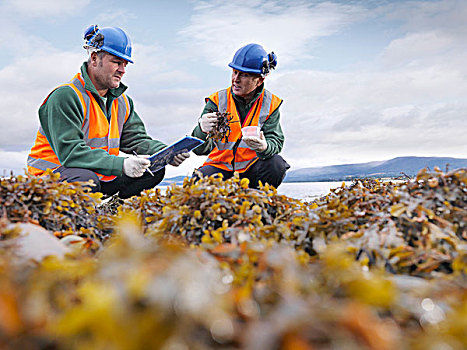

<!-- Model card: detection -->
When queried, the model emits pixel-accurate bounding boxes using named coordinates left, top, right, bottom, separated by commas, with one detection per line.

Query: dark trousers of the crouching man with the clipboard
left=54, top=166, right=165, bottom=199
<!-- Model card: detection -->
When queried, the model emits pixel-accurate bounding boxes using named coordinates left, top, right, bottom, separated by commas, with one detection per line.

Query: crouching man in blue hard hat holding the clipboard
left=27, top=25, right=189, bottom=198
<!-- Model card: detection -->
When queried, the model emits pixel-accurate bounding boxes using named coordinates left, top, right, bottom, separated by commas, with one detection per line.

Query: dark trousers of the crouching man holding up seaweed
left=193, top=154, right=290, bottom=188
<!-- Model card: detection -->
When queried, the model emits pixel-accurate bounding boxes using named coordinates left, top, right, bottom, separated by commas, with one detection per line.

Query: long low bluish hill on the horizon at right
left=284, top=157, right=467, bottom=182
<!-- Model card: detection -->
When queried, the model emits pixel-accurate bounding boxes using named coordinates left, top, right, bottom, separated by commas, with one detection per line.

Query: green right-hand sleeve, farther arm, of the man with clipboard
left=120, top=96, right=167, bottom=154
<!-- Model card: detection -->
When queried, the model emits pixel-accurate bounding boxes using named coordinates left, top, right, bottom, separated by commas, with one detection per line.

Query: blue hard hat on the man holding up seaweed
left=229, top=44, right=277, bottom=77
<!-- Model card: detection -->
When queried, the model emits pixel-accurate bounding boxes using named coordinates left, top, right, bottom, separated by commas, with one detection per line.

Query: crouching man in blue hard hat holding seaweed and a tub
left=192, top=44, right=290, bottom=188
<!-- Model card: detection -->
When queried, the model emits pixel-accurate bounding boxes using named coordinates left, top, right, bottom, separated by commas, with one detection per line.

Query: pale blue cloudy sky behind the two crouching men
left=0, top=0, right=467, bottom=177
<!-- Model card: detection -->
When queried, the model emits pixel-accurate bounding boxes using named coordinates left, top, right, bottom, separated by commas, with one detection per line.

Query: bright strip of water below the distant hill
left=277, top=181, right=348, bottom=200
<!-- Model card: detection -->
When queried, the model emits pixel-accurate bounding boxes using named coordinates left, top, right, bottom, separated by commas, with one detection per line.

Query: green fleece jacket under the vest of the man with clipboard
left=39, top=62, right=166, bottom=176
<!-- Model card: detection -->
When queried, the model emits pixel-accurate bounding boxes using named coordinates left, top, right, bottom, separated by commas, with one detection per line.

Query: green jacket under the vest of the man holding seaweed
left=191, top=84, right=284, bottom=159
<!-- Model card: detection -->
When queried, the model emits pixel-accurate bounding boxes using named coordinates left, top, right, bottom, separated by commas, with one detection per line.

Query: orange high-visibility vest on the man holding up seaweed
left=203, top=87, right=282, bottom=173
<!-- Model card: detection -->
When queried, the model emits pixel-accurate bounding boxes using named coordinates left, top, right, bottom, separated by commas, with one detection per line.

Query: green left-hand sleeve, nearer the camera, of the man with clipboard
left=39, top=86, right=124, bottom=176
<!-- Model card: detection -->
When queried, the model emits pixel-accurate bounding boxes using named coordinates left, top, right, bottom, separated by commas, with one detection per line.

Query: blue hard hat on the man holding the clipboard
left=84, top=25, right=133, bottom=63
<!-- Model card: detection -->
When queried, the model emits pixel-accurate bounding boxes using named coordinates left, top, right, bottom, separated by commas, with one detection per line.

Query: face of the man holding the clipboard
left=93, top=53, right=128, bottom=90
